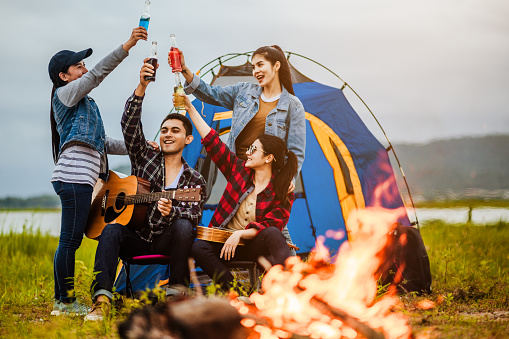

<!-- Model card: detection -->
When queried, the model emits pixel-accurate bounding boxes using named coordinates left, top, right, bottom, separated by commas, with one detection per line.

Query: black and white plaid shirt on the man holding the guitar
left=121, top=94, right=206, bottom=242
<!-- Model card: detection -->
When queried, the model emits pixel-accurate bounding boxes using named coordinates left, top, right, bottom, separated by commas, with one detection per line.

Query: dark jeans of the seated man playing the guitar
left=92, top=219, right=195, bottom=300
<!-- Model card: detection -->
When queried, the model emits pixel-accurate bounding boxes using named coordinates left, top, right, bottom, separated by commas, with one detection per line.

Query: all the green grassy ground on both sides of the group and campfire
left=0, top=221, right=509, bottom=338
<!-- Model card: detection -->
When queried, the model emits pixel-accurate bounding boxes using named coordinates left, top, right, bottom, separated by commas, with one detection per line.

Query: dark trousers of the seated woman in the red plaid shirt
left=191, top=227, right=292, bottom=291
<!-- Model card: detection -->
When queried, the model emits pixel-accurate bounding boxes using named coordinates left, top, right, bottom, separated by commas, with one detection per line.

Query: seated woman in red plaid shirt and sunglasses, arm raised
left=182, top=94, right=298, bottom=290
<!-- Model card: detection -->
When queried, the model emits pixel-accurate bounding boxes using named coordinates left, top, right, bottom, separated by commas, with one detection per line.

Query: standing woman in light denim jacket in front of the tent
left=177, top=45, right=306, bottom=253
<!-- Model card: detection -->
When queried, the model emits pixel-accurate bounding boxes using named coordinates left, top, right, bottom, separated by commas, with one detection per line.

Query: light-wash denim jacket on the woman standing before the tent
left=185, top=76, right=306, bottom=172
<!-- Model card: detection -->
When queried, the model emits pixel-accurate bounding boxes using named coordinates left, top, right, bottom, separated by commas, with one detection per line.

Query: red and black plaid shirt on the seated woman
left=202, top=130, right=295, bottom=233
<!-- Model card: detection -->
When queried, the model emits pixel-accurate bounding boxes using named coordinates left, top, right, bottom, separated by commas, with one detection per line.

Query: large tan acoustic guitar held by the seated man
left=85, top=171, right=201, bottom=239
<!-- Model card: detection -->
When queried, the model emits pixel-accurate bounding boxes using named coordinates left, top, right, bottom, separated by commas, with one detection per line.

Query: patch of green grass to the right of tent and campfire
left=403, top=221, right=509, bottom=338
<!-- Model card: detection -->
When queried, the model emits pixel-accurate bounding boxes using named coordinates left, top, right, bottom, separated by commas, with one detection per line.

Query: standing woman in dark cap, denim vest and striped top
left=48, top=27, right=147, bottom=315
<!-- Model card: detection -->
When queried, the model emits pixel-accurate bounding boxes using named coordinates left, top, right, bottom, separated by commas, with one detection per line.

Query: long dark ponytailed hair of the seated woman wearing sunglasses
left=258, top=134, right=297, bottom=206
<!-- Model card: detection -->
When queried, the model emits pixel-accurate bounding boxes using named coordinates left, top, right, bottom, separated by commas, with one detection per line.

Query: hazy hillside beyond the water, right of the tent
left=394, top=135, right=509, bottom=199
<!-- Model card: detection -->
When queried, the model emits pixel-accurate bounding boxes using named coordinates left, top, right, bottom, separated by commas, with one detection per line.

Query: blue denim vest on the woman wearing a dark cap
left=53, top=89, right=106, bottom=155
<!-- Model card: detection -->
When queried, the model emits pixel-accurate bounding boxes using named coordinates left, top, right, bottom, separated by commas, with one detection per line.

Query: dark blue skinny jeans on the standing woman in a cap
left=53, top=181, right=94, bottom=303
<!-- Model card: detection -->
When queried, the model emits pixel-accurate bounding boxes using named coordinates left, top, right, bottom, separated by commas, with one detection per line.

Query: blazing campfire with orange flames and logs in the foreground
left=121, top=197, right=412, bottom=339
